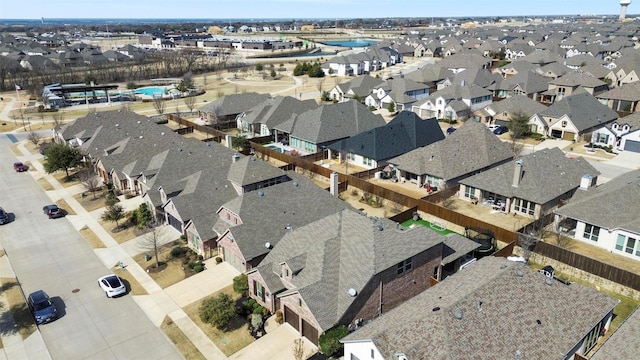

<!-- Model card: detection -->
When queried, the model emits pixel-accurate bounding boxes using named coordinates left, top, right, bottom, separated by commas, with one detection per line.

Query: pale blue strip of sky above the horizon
left=0, top=0, right=640, bottom=19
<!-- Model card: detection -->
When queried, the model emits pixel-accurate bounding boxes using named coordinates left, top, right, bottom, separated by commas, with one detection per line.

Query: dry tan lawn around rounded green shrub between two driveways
left=183, top=286, right=254, bottom=356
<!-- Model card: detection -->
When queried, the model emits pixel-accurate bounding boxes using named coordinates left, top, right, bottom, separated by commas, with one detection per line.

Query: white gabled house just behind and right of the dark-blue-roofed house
left=411, top=84, right=493, bottom=120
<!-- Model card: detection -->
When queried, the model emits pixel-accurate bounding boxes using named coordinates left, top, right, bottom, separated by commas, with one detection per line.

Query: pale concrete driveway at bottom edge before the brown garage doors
left=229, top=316, right=318, bottom=360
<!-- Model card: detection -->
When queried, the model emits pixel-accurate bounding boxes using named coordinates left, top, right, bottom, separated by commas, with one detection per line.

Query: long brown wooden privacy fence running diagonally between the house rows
left=167, top=114, right=640, bottom=291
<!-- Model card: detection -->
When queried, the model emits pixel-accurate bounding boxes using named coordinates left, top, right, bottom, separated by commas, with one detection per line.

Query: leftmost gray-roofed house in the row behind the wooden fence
left=198, top=92, right=271, bottom=127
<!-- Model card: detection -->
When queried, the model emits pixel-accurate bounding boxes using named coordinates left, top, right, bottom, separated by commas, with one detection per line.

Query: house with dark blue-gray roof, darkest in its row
left=328, top=111, right=444, bottom=169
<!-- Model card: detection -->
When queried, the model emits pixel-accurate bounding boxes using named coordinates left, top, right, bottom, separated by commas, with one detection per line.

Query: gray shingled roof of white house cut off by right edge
left=556, top=170, right=640, bottom=234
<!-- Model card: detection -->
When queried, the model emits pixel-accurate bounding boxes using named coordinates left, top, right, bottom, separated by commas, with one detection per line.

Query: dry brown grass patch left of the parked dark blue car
left=0, top=278, right=36, bottom=340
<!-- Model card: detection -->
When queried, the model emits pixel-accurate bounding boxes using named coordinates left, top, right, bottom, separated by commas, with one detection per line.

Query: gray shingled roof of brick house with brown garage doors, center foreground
left=261, top=210, right=460, bottom=329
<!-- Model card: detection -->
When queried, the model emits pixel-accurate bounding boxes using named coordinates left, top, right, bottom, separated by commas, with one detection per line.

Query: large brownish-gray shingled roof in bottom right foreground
left=341, top=256, right=618, bottom=360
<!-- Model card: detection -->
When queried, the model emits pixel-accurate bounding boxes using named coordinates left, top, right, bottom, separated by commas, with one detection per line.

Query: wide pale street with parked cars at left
left=0, top=134, right=183, bottom=360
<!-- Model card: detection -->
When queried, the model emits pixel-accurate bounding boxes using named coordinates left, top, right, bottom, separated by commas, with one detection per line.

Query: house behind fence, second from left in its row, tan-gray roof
left=236, top=96, right=318, bottom=142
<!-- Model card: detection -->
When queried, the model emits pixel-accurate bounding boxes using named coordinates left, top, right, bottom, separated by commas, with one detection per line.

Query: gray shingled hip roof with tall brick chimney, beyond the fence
left=460, top=148, right=600, bottom=204
